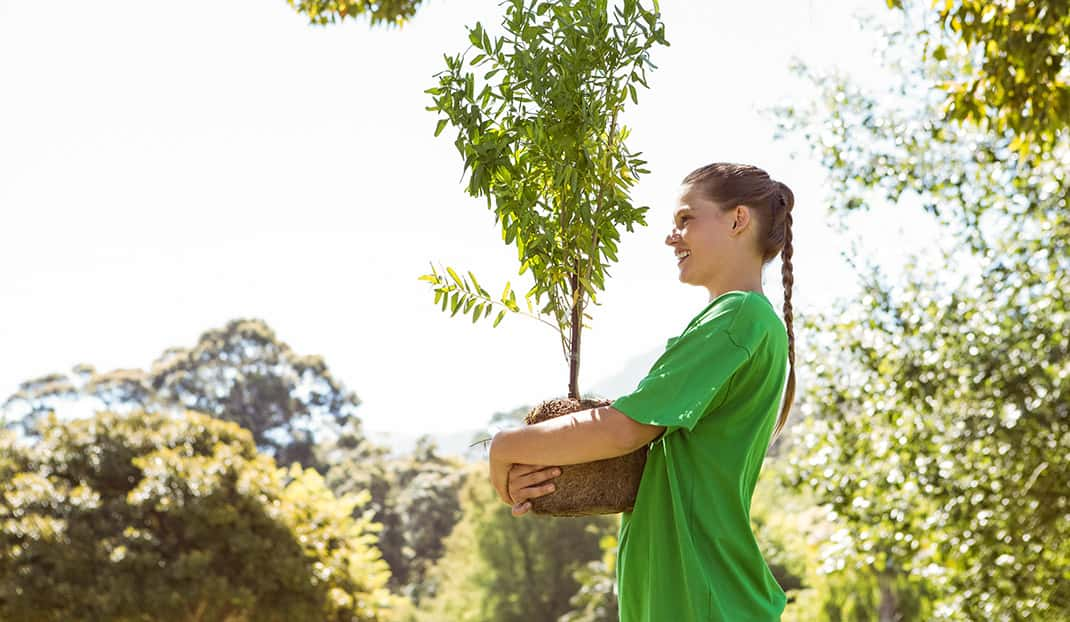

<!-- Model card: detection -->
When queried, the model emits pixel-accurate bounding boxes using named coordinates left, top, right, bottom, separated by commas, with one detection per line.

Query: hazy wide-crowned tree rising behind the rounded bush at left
left=4, top=319, right=363, bottom=471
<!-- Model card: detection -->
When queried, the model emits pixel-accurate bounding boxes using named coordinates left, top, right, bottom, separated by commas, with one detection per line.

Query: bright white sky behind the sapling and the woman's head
left=0, top=0, right=928, bottom=433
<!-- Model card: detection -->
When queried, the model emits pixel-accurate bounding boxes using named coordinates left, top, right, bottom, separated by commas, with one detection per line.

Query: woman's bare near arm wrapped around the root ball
left=490, top=406, right=664, bottom=505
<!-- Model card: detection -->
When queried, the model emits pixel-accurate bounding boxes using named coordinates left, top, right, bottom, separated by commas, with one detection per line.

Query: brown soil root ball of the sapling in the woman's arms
left=524, top=397, right=646, bottom=516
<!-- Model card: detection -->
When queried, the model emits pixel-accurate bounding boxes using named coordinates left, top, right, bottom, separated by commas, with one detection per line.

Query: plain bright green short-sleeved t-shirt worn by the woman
left=613, top=291, right=788, bottom=622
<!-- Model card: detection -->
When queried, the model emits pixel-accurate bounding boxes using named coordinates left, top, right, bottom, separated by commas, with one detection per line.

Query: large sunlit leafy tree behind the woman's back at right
left=780, top=9, right=1070, bottom=620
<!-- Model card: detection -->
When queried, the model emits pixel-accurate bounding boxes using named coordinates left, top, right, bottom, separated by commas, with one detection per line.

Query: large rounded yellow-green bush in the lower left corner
left=0, top=412, right=393, bottom=621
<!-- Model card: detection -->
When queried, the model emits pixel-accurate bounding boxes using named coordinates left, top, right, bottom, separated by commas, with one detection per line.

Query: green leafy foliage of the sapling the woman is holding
left=422, top=0, right=668, bottom=378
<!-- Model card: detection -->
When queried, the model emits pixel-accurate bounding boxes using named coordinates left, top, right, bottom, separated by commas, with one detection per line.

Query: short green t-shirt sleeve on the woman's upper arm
left=612, top=321, right=750, bottom=435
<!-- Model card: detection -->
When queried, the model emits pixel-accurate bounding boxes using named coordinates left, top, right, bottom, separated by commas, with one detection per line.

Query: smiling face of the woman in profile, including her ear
left=666, top=185, right=749, bottom=287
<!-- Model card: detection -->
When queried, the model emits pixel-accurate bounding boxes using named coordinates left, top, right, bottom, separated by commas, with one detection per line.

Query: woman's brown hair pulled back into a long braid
left=684, top=162, right=795, bottom=438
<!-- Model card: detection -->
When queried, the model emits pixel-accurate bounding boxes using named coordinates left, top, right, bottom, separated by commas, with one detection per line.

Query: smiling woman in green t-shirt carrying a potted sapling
left=490, top=164, right=795, bottom=622
